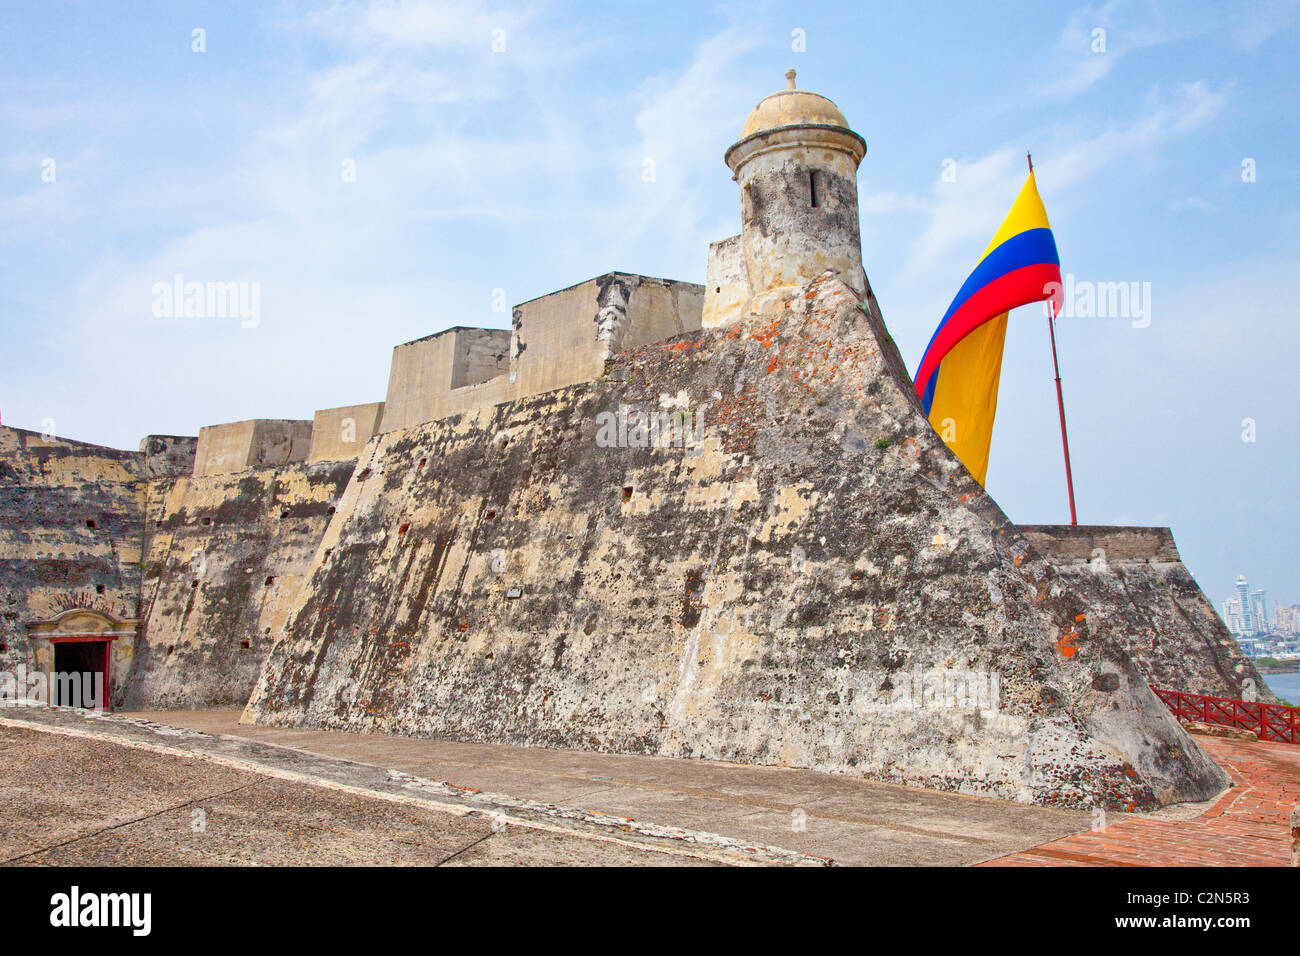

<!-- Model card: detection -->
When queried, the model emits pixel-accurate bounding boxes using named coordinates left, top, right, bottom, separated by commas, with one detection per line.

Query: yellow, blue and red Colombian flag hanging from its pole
left=917, top=169, right=1061, bottom=485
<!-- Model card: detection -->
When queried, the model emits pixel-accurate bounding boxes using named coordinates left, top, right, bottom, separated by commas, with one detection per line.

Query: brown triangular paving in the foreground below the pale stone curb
left=0, top=722, right=716, bottom=871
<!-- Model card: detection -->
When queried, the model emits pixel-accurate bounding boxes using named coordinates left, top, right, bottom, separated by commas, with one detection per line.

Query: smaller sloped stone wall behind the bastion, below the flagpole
left=1018, top=525, right=1277, bottom=701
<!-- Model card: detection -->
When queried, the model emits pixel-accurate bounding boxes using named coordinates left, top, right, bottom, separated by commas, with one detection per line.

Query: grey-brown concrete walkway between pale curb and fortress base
left=0, top=709, right=1089, bottom=865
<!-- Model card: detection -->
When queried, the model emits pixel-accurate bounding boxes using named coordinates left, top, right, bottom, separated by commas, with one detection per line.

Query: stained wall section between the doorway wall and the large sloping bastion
left=122, top=460, right=355, bottom=710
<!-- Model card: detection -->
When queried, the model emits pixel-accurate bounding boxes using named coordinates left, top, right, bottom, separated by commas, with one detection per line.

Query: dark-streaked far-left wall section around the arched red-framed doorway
left=0, top=427, right=147, bottom=704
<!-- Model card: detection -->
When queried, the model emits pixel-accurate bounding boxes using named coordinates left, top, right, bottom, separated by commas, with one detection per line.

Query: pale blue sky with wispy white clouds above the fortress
left=0, top=0, right=1300, bottom=602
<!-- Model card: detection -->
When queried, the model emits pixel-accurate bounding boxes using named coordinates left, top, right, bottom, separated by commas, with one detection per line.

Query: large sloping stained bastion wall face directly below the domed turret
left=246, top=278, right=1227, bottom=809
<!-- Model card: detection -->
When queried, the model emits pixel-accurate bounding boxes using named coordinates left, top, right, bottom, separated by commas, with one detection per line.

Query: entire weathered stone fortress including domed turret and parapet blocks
left=0, top=74, right=1269, bottom=809
